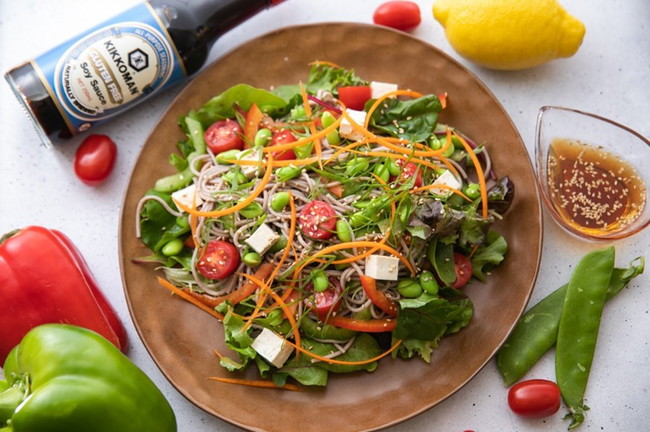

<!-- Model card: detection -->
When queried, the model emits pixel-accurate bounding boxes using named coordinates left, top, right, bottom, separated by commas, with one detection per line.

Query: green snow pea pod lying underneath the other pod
left=497, top=257, right=645, bottom=386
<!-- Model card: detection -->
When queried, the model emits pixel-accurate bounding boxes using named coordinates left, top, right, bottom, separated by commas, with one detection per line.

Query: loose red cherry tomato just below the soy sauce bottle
left=74, top=134, right=117, bottom=186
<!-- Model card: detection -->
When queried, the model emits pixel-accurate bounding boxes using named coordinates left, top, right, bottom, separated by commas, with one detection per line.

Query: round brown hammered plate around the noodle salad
left=120, top=23, right=542, bottom=432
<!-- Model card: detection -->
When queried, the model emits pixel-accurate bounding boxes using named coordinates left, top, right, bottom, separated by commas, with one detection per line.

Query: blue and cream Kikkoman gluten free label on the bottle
left=33, top=3, right=185, bottom=133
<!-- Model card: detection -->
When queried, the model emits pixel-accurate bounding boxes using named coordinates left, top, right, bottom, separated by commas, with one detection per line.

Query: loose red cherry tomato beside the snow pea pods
left=508, top=379, right=561, bottom=418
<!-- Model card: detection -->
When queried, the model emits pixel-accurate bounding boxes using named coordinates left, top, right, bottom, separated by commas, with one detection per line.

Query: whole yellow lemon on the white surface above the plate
left=433, top=0, right=585, bottom=70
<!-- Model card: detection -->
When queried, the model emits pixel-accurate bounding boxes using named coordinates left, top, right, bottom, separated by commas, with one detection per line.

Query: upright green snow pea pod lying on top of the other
left=555, top=246, right=614, bottom=429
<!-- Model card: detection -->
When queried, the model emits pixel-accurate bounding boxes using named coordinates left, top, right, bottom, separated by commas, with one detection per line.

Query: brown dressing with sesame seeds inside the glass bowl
left=547, top=138, right=646, bottom=236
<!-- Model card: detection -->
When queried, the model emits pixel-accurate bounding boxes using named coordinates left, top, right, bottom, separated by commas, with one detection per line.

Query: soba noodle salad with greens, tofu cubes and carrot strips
left=137, top=62, right=514, bottom=388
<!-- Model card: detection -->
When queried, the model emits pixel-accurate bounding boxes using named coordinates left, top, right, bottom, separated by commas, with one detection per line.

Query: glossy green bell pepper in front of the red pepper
left=0, top=324, right=177, bottom=432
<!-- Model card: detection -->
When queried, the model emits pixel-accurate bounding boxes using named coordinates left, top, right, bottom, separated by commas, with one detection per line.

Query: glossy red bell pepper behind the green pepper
left=0, top=226, right=128, bottom=364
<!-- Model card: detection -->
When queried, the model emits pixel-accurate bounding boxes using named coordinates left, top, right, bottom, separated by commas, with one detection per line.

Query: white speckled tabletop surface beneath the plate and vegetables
left=0, top=0, right=650, bottom=432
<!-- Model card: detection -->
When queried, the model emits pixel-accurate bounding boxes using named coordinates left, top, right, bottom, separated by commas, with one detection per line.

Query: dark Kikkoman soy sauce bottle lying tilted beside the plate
left=5, top=0, right=284, bottom=146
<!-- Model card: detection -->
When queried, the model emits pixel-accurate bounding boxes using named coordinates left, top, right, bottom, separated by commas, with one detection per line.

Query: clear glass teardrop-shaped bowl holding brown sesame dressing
left=535, top=106, right=650, bottom=241
